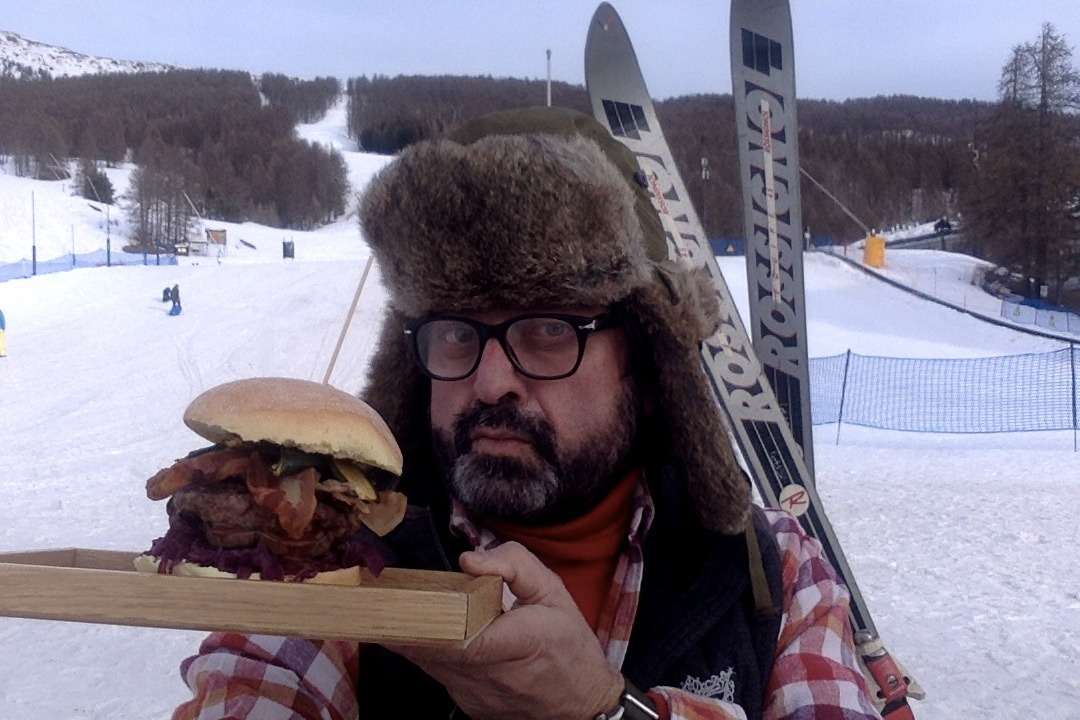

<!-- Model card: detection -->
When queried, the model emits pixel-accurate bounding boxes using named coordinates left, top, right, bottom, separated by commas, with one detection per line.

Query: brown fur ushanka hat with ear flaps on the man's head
left=360, top=108, right=750, bottom=534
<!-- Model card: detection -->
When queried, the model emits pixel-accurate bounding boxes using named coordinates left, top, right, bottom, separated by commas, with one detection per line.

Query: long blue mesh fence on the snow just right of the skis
left=810, top=345, right=1080, bottom=433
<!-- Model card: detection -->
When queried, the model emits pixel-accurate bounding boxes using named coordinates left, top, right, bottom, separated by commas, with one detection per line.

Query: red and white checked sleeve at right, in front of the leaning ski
left=652, top=510, right=881, bottom=720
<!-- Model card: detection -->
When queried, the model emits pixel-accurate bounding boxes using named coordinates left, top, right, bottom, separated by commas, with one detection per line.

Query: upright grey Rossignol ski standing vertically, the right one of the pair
left=731, top=0, right=813, bottom=474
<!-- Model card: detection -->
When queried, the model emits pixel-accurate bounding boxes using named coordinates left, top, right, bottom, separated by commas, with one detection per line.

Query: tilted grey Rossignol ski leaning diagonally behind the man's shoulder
left=585, top=2, right=921, bottom=720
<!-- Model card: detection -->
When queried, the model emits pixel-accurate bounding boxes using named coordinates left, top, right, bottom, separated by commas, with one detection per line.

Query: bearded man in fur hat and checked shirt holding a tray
left=176, top=108, right=878, bottom=720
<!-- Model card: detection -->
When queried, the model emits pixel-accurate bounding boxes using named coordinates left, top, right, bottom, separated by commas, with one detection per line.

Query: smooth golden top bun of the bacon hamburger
left=184, top=378, right=402, bottom=475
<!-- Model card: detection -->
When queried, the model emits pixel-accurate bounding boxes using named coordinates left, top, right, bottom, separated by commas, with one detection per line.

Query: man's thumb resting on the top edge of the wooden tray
left=459, top=543, right=577, bottom=609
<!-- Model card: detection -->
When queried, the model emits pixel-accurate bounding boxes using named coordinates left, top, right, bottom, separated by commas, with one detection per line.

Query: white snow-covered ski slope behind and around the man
left=0, top=104, right=1080, bottom=720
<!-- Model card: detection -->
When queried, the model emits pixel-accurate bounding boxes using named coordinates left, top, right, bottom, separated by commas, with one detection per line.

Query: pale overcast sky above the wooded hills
left=0, top=0, right=1080, bottom=100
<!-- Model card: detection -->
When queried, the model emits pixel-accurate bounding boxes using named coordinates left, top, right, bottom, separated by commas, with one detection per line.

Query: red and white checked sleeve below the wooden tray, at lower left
left=173, top=633, right=359, bottom=720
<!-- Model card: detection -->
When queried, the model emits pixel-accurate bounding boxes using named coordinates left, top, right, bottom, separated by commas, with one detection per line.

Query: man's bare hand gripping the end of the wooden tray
left=391, top=543, right=623, bottom=720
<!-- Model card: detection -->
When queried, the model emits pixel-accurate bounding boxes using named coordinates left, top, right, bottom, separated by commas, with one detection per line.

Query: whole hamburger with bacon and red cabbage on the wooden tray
left=135, top=378, right=406, bottom=584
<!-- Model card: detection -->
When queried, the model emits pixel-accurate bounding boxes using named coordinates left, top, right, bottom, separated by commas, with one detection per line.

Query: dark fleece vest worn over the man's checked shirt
left=357, top=468, right=783, bottom=719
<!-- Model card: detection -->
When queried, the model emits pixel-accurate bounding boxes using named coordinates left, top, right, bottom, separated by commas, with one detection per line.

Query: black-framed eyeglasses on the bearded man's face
left=405, top=313, right=618, bottom=380
